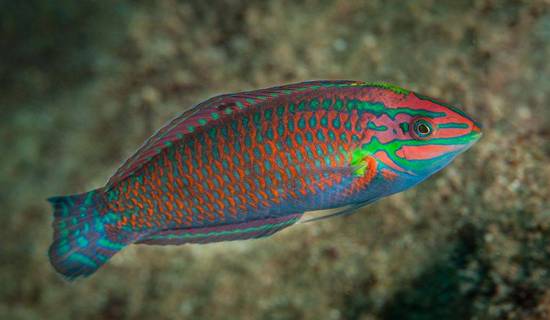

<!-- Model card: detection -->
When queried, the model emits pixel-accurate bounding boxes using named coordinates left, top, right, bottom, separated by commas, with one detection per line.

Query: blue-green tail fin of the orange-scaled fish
left=48, top=189, right=133, bottom=280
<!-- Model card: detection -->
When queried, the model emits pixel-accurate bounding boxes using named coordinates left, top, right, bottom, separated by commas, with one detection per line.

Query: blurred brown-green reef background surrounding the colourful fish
left=0, top=0, right=550, bottom=320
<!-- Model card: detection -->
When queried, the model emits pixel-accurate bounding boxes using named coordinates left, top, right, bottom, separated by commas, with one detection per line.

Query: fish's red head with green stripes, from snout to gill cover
left=355, top=89, right=481, bottom=195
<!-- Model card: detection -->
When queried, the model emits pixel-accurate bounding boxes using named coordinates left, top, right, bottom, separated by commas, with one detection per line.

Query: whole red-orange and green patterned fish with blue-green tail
left=48, top=80, right=481, bottom=280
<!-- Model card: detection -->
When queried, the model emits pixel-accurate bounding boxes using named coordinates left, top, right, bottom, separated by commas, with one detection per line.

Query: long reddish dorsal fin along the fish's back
left=107, top=80, right=364, bottom=187
